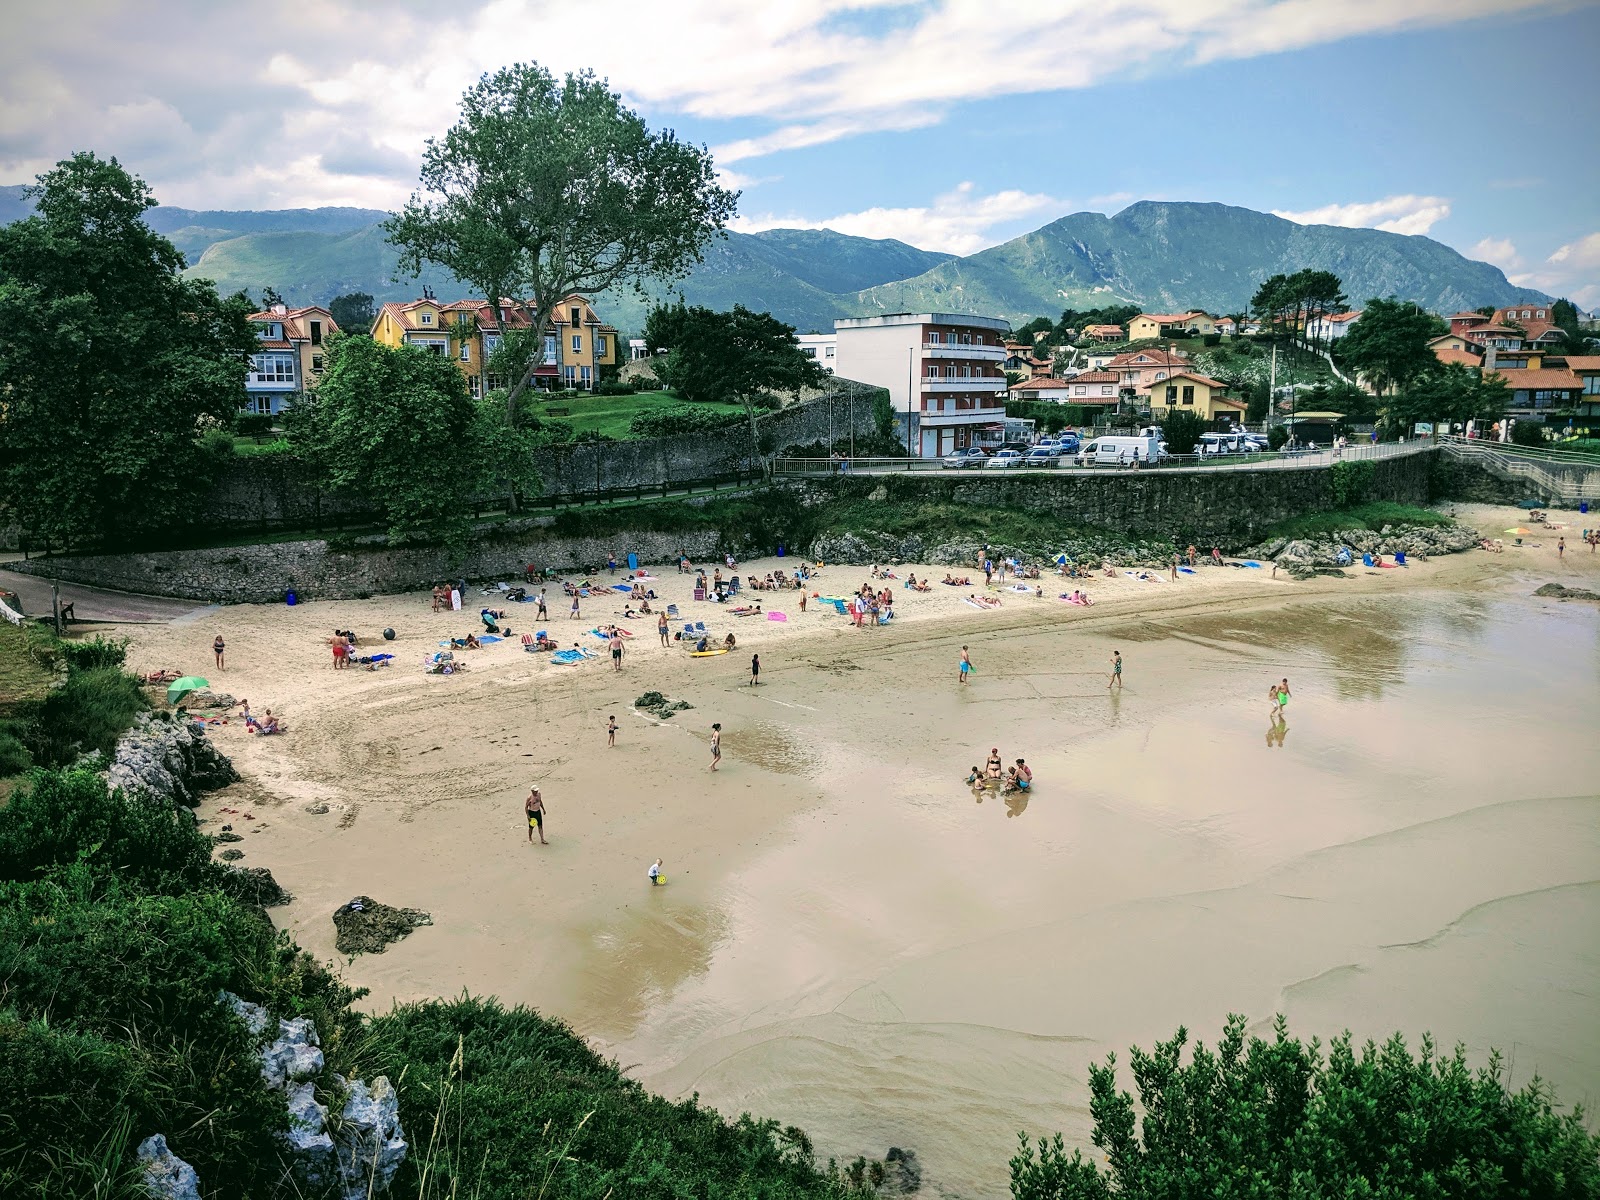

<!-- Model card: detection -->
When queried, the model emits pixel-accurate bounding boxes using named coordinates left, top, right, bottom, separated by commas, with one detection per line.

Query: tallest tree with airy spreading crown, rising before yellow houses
left=386, top=62, right=739, bottom=422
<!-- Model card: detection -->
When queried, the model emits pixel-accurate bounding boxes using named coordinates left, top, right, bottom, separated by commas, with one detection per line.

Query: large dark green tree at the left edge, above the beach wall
left=0, top=154, right=256, bottom=544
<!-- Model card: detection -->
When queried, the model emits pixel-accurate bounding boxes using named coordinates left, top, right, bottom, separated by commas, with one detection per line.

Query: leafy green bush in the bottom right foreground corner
left=1011, top=1016, right=1600, bottom=1200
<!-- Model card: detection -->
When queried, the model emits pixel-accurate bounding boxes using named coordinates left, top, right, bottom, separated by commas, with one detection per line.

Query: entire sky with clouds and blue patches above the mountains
left=0, top=0, right=1600, bottom=307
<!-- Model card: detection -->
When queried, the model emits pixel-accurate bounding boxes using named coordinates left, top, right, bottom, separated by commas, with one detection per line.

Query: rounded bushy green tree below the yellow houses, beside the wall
left=299, top=334, right=539, bottom=547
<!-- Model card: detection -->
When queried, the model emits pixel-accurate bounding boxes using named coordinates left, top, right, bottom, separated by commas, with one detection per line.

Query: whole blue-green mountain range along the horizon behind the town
left=0, top=187, right=1550, bottom=333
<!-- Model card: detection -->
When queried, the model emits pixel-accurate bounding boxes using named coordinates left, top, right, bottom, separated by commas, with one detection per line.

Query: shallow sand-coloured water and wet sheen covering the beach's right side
left=562, top=594, right=1600, bottom=1197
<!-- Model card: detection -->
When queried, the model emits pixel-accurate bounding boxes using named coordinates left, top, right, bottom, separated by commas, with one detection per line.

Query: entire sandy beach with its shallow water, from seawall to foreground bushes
left=112, top=509, right=1600, bottom=1197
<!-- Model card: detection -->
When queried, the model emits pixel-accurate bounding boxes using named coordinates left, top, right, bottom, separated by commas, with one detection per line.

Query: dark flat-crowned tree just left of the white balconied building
left=645, top=301, right=827, bottom=476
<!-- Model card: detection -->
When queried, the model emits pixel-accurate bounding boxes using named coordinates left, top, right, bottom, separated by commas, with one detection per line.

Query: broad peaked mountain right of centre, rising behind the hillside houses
left=850, top=202, right=1547, bottom=322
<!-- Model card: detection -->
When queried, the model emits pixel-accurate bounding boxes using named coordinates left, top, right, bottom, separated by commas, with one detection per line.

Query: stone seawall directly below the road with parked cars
left=798, top=451, right=1437, bottom=546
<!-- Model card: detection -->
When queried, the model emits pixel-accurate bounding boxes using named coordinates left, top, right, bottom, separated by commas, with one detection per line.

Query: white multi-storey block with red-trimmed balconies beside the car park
left=834, top=312, right=1011, bottom=458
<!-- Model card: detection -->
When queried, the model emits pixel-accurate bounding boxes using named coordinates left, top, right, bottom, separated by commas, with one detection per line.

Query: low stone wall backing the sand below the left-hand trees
left=11, top=518, right=718, bottom=603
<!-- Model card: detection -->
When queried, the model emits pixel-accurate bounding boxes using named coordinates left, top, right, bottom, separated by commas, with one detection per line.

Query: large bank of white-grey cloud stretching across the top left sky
left=0, top=0, right=1568, bottom=208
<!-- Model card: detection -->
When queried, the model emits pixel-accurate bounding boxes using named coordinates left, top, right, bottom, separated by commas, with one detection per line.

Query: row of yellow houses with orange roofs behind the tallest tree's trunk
left=373, top=296, right=618, bottom=395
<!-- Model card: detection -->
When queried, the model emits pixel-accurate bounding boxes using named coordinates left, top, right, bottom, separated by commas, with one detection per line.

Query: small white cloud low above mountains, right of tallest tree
left=734, top=181, right=1064, bottom=254
